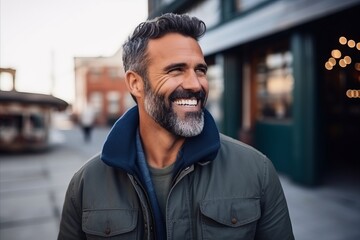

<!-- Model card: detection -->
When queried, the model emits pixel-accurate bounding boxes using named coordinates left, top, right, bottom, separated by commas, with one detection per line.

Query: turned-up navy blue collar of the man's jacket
left=101, top=106, right=220, bottom=174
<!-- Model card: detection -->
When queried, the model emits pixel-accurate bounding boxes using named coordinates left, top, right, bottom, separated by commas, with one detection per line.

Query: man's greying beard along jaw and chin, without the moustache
left=144, top=85, right=204, bottom=137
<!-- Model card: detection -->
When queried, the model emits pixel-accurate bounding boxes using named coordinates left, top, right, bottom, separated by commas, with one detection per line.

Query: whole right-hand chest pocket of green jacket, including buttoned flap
left=200, top=198, right=261, bottom=240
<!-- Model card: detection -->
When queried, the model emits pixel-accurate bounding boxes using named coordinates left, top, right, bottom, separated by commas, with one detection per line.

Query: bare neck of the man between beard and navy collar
left=140, top=120, right=185, bottom=168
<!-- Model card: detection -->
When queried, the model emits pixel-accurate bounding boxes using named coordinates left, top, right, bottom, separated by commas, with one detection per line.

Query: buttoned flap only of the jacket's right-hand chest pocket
left=200, top=198, right=261, bottom=227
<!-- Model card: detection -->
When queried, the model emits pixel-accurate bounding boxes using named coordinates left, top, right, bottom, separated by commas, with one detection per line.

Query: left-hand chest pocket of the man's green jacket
left=82, top=209, right=139, bottom=240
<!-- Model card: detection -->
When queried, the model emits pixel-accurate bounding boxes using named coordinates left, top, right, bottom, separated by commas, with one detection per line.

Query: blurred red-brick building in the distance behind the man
left=74, top=51, right=134, bottom=126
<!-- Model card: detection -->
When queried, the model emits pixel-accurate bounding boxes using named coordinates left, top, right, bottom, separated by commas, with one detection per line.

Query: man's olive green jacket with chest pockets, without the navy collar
left=58, top=107, right=294, bottom=240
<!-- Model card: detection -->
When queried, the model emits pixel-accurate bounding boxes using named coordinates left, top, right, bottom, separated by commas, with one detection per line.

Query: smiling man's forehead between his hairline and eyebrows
left=147, top=33, right=204, bottom=65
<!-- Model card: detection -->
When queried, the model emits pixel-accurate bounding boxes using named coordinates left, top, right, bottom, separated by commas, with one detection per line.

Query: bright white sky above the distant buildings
left=0, top=0, right=147, bottom=103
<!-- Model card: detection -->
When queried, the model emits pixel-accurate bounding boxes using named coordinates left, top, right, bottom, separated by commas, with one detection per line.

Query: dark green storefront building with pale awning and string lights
left=148, top=0, right=360, bottom=185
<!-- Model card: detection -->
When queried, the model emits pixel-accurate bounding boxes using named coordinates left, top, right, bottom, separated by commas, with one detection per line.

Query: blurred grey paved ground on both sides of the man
left=0, top=128, right=360, bottom=240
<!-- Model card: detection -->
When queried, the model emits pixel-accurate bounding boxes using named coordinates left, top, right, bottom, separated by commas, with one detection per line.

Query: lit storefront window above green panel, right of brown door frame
left=256, top=51, right=294, bottom=120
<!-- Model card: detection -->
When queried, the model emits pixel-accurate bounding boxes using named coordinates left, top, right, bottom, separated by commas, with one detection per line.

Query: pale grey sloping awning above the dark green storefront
left=200, top=0, right=360, bottom=56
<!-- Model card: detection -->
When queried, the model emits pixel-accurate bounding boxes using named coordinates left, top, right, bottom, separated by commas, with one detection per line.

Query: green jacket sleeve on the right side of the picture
left=255, top=158, right=294, bottom=240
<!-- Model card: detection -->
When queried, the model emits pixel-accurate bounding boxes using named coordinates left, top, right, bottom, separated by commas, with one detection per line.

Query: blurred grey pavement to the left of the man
left=0, top=128, right=109, bottom=240
